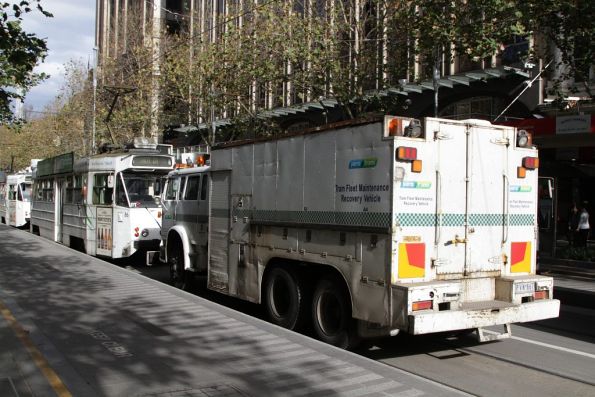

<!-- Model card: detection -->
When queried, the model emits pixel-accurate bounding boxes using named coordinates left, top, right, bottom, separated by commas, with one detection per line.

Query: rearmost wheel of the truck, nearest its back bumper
left=312, top=278, right=357, bottom=349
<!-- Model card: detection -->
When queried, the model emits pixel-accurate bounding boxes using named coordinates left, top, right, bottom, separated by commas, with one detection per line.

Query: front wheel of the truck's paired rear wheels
left=264, top=267, right=305, bottom=330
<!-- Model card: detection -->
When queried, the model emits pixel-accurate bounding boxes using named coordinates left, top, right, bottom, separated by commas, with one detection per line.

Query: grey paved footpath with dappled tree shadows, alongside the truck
left=0, top=225, right=470, bottom=397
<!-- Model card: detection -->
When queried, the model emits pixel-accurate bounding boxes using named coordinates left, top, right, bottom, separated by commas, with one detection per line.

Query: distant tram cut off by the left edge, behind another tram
left=0, top=160, right=37, bottom=229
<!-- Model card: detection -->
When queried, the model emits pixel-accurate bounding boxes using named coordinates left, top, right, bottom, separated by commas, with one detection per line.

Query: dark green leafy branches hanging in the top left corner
left=0, top=0, right=52, bottom=125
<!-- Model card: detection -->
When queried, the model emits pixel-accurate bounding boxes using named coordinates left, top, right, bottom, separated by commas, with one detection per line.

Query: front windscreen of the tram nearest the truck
left=116, top=172, right=160, bottom=208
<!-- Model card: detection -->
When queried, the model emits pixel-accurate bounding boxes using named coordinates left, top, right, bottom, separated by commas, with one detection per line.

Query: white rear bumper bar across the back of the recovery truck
left=408, top=299, right=560, bottom=335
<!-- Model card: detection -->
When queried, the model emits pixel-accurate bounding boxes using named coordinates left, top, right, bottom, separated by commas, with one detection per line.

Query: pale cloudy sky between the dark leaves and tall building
left=23, top=0, right=95, bottom=111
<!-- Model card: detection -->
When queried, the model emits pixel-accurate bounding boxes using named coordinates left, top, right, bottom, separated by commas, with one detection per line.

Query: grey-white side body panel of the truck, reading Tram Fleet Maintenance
left=210, top=123, right=392, bottom=323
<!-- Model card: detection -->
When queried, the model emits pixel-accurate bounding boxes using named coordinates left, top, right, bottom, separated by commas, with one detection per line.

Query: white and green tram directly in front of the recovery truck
left=31, top=138, right=174, bottom=259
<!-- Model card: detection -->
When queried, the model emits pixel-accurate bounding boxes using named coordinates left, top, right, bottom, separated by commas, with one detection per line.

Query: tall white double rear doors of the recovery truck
left=428, top=121, right=507, bottom=276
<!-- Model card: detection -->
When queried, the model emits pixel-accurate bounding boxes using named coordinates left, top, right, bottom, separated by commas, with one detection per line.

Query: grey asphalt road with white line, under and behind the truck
left=125, top=263, right=595, bottom=397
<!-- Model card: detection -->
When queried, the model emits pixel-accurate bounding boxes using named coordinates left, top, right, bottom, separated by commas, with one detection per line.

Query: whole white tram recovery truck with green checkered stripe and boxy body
left=162, top=116, right=560, bottom=348
